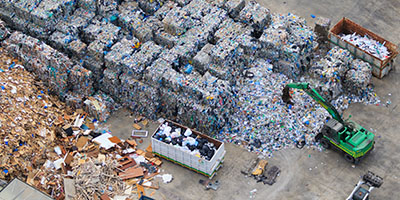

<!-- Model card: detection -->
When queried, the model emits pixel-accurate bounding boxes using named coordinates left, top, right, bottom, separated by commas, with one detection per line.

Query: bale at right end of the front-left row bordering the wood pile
left=68, top=65, right=94, bottom=96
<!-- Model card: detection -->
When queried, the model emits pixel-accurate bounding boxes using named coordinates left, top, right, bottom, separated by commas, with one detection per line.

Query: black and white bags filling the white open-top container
left=153, top=122, right=216, bottom=160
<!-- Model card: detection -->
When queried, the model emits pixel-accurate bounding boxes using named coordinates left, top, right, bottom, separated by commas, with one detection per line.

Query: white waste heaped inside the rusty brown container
left=340, top=33, right=390, bottom=60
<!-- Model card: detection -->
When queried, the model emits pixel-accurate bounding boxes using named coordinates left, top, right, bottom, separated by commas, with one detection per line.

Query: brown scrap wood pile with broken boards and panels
left=0, top=50, right=166, bottom=199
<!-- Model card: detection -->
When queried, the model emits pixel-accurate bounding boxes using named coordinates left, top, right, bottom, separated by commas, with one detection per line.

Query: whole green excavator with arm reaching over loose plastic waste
left=282, top=83, right=375, bottom=163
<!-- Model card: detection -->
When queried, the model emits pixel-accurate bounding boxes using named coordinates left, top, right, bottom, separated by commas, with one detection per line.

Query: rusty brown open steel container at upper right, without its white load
left=328, top=18, right=399, bottom=78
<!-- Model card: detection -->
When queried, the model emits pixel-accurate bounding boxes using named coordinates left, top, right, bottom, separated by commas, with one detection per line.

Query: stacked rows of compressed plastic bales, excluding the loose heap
left=0, top=0, right=374, bottom=132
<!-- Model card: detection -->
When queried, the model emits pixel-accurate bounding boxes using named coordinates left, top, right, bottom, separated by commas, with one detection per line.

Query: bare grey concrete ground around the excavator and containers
left=107, top=0, right=400, bottom=200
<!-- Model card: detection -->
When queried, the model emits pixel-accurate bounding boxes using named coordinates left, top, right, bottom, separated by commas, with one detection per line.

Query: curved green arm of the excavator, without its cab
left=282, top=83, right=344, bottom=124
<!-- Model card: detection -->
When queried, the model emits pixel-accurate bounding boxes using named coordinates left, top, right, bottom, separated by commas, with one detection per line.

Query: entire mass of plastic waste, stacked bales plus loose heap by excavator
left=0, top=0, right=384, bottom=161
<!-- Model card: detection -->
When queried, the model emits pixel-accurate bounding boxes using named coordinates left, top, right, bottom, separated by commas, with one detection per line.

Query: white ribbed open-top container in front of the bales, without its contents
left=151, top=120, right=226, bottom=179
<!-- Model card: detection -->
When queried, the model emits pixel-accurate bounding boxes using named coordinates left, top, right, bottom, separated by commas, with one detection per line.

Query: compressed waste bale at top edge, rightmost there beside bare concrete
left=239, top=0, right=271, bottom=32
